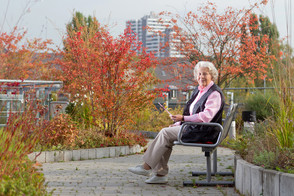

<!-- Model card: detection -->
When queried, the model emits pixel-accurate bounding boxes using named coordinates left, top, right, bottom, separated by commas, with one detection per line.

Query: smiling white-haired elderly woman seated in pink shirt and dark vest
left=129, top=61, right=225, bottom=184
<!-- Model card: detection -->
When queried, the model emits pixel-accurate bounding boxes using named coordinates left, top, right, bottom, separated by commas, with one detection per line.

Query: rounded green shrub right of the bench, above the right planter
left=245, top=92, right=279, bottom=121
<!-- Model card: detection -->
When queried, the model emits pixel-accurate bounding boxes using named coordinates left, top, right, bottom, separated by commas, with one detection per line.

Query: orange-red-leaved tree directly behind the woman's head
left=161, top=1, right=274, bottom=87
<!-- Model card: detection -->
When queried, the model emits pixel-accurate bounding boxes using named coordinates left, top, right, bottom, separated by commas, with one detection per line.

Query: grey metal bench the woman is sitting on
left=174, top=104, right=238, bottom=186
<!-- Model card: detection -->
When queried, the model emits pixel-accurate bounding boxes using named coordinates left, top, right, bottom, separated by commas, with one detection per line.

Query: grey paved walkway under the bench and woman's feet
left=42, top=142, right=239, bottom=196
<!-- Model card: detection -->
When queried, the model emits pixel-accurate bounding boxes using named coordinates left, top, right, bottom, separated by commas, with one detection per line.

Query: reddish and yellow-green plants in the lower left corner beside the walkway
left=0, top=104, right=48, bottom=195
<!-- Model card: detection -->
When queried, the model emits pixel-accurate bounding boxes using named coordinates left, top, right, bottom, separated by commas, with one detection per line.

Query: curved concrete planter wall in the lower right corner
left=235, top=155, right=294, bottom=196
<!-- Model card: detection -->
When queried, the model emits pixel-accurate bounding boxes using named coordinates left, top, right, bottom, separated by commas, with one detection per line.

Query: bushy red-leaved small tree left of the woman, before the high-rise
left=58, top=15, right=156, bottom=135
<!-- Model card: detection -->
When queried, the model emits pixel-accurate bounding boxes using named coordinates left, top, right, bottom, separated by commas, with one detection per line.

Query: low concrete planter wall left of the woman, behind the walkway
left=28, top=145, right=145, bottom=163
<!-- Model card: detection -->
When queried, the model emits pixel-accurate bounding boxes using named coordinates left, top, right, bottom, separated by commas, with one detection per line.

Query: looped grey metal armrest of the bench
left=175, top=122, right=223, bottom=148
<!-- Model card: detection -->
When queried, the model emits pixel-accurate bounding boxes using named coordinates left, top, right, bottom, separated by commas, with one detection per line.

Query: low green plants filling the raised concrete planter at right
left=229, top=119, right=294, bottom=173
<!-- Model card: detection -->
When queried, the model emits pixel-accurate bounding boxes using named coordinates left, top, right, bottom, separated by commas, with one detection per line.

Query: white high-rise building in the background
left=126, top=12, right=181, bottom=57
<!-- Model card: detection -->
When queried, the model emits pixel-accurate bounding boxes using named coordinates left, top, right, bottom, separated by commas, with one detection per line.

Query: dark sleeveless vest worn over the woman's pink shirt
left=182, top=84, right=225, bottom=143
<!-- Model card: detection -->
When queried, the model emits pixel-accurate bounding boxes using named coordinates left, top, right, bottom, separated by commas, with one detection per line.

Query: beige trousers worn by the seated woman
left=143, top=126, right=181, bottom=175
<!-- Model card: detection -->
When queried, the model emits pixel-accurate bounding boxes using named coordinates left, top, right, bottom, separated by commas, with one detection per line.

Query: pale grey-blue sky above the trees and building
left=0, top=0, right=294, bottom=47
